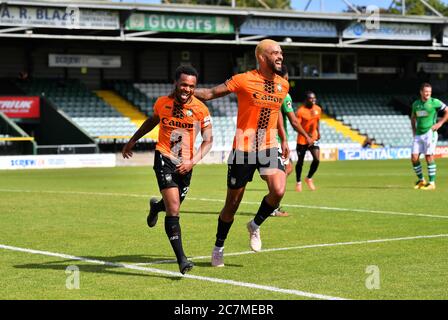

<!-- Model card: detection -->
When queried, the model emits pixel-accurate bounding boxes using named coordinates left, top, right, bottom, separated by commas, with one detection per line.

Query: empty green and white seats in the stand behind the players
left=11, top=79, right=448, bottom=149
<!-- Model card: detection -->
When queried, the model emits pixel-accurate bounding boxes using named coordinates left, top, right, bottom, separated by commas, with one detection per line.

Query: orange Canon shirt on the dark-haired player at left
left=154, top=96, right=211, bottom=161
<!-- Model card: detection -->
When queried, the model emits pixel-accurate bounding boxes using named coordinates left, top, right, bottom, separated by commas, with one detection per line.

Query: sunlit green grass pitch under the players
left=0, top=159, right=448, bottom=300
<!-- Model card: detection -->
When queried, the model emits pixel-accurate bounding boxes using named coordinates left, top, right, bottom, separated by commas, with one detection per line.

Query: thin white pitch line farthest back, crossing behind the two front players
left=0, top=189, right=448, bottom=219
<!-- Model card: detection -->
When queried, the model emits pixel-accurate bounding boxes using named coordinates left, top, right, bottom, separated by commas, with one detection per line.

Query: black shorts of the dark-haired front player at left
left=154, top=150, right=193, bottom=192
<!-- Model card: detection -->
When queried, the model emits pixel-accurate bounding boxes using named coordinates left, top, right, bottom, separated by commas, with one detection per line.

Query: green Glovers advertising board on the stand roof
left=126, top=13, right=234, bottom=33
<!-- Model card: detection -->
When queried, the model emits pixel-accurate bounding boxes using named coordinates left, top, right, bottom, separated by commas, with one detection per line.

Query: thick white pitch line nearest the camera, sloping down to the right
left=0, top=244, right=346, bottom=300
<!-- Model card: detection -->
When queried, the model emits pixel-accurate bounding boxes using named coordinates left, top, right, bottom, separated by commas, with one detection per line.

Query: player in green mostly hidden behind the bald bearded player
left=271, top=65, right=313, bottom=217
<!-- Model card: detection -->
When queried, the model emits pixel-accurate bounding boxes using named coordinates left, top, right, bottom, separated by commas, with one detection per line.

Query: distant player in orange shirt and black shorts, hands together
left=296, top=91, right=322, bottom=192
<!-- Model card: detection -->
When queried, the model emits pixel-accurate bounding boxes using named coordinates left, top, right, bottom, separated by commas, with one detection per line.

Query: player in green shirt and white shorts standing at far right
left=411, top=83, right=448, bottom=190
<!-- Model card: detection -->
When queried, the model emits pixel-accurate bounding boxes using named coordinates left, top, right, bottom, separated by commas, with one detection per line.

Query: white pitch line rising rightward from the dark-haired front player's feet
left=135, top=234, right=448, bottom=266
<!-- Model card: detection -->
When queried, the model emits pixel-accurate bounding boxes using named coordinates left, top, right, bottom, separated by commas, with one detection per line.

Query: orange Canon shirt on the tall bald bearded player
left=225, top=70, right=289, bottom=152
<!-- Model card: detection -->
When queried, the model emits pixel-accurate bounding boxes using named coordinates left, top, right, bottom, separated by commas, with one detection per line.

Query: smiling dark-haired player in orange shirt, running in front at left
left=122, top=66, right=213, bottom=274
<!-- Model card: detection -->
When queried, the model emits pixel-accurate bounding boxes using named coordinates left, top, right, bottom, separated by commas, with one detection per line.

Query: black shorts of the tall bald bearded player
left=227, top=148, right=285, bottom=189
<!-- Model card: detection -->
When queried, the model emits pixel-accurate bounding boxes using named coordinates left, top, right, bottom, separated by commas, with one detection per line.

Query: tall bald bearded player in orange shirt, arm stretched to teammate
left=195, top=39, right=289, bottom=267
